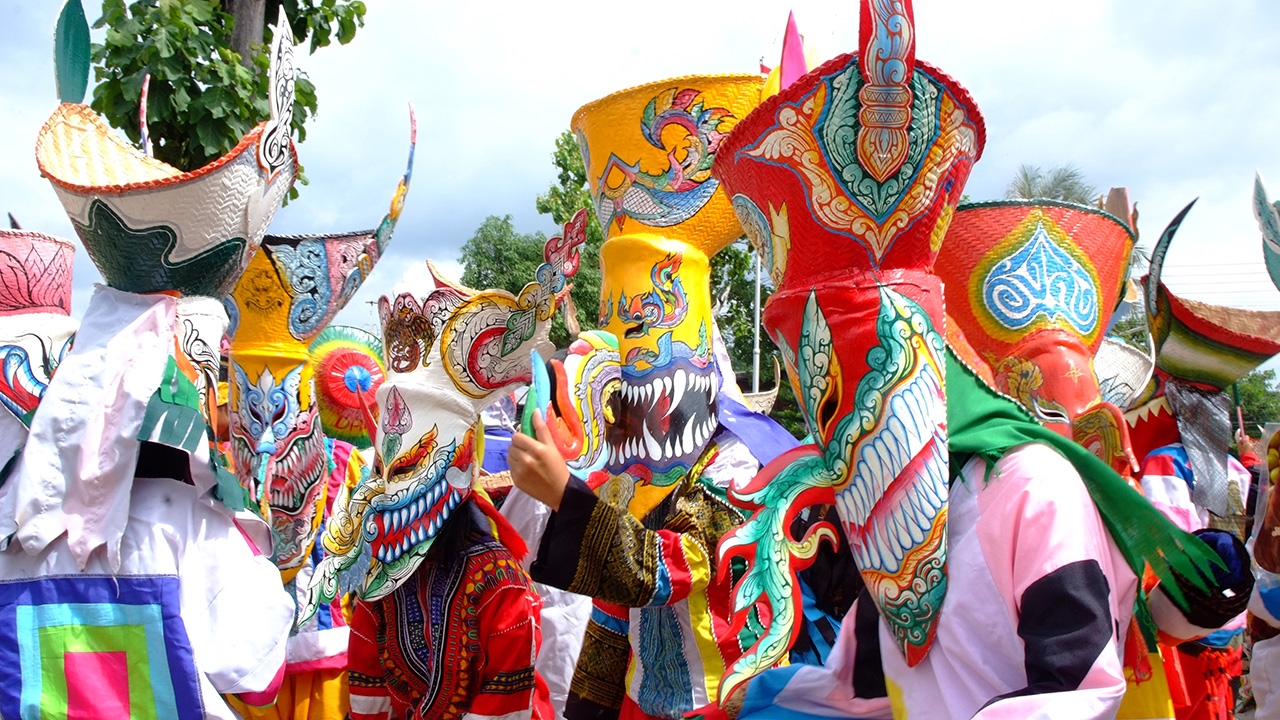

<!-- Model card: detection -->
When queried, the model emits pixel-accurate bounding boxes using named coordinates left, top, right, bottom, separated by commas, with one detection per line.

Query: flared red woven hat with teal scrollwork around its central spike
left=712, top=54, right=986, bottom=290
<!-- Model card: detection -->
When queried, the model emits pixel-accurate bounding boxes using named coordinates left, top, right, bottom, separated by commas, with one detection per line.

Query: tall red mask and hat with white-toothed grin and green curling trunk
left=714, top=3, right=983, bottom=697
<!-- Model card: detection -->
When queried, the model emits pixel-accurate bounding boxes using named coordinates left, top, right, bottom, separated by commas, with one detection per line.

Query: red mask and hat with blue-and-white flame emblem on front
left=937, top=200, right=1137, bottom=474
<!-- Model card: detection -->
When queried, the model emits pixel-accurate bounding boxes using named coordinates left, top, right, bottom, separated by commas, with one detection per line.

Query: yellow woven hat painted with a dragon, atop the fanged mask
left=571, top=74, right=764, bottom=258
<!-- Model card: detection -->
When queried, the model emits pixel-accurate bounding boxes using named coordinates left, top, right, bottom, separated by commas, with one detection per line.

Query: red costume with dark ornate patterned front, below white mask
left=349, top=515, right=556, bottom=720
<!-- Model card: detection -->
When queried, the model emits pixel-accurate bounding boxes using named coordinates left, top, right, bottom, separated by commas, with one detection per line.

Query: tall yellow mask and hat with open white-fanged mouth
left=572, top=76, right=763, bottom=499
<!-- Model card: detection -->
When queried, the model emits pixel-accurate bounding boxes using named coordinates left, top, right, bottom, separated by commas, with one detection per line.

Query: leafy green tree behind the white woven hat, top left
left=86, top=0, right=365, bottom=176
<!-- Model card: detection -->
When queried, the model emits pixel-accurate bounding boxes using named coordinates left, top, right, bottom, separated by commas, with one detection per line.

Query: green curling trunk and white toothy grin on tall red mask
left=721, top=287, right=947, bottom=697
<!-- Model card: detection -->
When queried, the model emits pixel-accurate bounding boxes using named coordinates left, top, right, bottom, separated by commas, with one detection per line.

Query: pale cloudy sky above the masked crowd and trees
left=0, top=0, right=1280, bottom=351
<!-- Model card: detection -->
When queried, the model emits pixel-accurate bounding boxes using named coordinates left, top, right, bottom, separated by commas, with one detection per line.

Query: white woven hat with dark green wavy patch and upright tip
left=36, top=18, right=297, bottom=297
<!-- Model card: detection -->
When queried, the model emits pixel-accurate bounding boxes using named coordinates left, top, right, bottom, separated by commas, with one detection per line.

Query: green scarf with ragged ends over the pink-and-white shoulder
left=946, top=348, right=1222, bottom=614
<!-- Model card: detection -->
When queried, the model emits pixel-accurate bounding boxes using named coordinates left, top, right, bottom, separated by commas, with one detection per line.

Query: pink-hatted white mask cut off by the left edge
left=0, top=229, right=77, bottom=471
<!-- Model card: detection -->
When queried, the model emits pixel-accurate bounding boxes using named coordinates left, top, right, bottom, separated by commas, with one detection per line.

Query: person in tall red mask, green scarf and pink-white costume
left=713, top=3, right=1208, bottom=719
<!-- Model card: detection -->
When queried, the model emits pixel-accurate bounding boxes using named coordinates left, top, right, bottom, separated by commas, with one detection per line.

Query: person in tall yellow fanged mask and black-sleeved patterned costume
left=519, top=76, right=795, bottom=720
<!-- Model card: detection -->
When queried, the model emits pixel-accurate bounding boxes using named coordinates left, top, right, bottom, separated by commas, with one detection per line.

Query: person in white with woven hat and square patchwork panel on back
left=0, top=15, right=296, bottom=717
